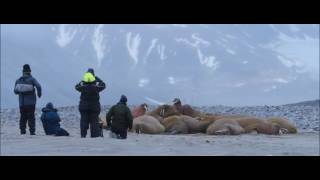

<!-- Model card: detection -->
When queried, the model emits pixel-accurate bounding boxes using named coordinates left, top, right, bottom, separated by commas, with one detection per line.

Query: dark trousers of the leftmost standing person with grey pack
left=20, top=105, right=36, bottom=134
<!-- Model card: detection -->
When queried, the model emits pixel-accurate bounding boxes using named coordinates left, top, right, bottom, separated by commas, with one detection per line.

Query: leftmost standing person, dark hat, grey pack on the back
left=14, top=64, right=41, bottom=135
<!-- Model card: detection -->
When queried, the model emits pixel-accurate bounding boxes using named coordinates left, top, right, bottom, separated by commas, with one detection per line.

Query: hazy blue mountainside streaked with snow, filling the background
left=1, top=24, right=319, bottom=107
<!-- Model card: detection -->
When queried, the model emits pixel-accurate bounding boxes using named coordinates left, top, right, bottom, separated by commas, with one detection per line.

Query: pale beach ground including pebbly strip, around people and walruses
left=1, top=106, right=320, bottom=156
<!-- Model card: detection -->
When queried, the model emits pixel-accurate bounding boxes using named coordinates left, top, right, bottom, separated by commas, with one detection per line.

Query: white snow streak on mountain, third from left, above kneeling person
left=127, top=32, right=141, bottom=64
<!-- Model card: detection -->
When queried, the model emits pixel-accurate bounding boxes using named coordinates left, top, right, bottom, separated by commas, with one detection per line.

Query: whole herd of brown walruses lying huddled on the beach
left=100, top=98, right=297, bottom=135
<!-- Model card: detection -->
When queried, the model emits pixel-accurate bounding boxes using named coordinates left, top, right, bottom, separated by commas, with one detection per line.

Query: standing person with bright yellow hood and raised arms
left=75, top=68, right=106, bottom=138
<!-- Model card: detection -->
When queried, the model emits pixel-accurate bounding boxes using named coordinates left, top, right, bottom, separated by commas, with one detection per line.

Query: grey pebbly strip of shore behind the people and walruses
left=1, top=105, right=320, bottom=131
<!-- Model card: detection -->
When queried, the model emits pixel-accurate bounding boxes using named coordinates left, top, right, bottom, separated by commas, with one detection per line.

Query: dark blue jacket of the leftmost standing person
left=14, top=74, right=41, bottom=107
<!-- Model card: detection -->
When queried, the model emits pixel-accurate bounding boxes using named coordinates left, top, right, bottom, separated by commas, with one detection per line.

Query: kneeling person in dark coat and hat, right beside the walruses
left=106, top=95, right=132, bottom=139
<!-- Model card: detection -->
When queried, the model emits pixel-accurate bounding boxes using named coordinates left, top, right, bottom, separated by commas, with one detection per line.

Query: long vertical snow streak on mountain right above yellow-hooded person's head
left=92, top=24, right=106, bottom=67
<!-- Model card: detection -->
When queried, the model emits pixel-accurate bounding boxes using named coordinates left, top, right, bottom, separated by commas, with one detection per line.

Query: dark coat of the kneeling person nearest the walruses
left=106, top=102, right=133, bottom=130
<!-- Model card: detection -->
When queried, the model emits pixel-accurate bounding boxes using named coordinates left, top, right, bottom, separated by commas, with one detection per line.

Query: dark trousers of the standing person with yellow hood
left=80, top=109, right=101, bottom=137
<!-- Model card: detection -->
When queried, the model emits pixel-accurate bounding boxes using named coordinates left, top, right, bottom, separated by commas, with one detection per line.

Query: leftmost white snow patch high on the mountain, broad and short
left=56, top=24, right=77, bottom=48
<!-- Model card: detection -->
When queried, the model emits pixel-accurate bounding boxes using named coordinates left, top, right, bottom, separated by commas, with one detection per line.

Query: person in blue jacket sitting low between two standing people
left=41, top=103, right=69, bottom=136
